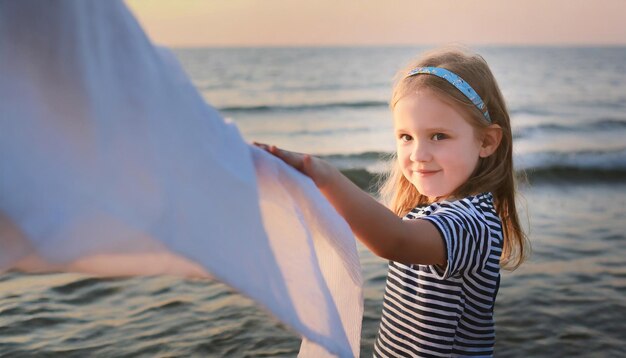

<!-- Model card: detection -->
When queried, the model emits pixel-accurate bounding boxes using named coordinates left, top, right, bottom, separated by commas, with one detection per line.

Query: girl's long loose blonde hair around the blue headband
left=380, top=47, right=530, bottom=270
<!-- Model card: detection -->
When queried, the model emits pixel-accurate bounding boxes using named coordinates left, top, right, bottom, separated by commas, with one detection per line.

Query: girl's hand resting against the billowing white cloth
left=253, top=142, right=334, bottom=189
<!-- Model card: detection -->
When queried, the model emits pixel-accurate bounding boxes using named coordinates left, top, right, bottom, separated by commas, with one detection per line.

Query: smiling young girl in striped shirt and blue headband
left=257, top=49, right=528, bottom=357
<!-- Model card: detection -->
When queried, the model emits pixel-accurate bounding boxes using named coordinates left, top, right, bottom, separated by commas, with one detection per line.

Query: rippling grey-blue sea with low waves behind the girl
left=0, top=46, right=626, bottom=357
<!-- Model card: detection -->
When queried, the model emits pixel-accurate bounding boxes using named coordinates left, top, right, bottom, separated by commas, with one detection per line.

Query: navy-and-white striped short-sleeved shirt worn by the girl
left=374, top=193, right=502, bottom=357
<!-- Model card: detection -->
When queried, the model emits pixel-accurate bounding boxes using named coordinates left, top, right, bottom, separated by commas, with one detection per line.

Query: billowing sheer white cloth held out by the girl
left=0, top=0, right=363, bottom=357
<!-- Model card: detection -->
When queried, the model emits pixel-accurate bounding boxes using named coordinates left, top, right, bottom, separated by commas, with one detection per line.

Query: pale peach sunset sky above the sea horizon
left=125, top=0, right=626, bottom=47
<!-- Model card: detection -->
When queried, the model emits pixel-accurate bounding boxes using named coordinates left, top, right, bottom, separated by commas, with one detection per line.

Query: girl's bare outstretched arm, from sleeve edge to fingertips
left=254, top=143, right=446, bottom=265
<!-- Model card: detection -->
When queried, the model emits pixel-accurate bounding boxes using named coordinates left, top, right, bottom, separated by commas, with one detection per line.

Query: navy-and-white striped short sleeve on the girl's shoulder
left=420, top=199, right=491, bottom=279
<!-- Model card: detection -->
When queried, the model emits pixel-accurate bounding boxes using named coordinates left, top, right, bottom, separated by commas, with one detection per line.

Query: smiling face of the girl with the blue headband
left=393, top=90, right=482, bottom=202
